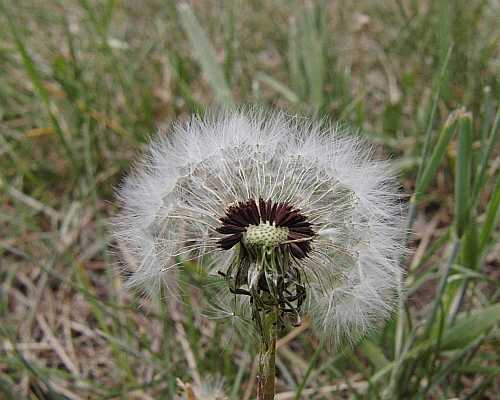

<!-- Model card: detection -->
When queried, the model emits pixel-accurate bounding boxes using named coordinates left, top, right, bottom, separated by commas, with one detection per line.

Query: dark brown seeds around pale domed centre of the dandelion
left=217, top=198, right=315, bottom=259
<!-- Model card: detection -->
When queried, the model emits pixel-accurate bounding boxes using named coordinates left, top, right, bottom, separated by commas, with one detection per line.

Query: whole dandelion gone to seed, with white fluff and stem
left=115, top=110, right=404, bottom=399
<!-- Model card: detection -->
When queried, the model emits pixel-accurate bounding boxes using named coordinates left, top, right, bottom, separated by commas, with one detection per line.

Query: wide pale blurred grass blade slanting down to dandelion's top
left=178, top=3, right=233, bottom=104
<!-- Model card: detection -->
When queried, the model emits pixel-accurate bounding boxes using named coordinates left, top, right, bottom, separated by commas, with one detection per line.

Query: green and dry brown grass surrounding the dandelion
left=0, top=0, right=500, bottom=400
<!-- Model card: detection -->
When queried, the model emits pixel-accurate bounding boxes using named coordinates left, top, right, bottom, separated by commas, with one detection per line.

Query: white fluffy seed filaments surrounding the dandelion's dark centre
left=115, top=110, right=404, bottom=339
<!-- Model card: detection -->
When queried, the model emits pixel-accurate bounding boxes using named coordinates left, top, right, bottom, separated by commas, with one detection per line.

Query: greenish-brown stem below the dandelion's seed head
left=257, top=306, right=278, bottom=400
